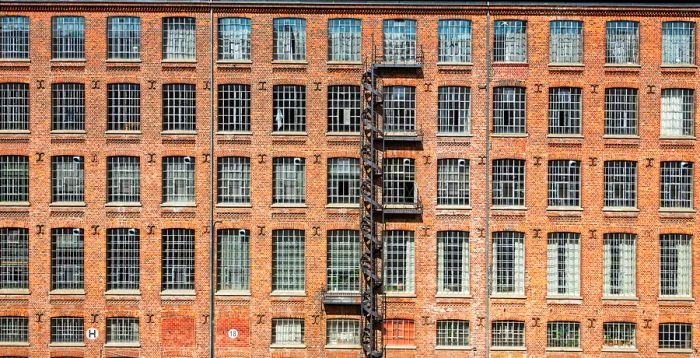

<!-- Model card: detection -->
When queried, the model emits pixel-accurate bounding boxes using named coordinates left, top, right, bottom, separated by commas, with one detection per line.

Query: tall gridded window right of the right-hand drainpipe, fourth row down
left=492, top=231, right=525, bottom=295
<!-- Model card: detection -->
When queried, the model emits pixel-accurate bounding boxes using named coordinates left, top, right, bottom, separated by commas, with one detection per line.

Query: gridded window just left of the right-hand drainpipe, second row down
left=438, top=86, right=471, bottom=135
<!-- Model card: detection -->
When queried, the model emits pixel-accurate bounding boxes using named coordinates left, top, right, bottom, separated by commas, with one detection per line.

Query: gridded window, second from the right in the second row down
left=605, top=88, right=638, bottom=136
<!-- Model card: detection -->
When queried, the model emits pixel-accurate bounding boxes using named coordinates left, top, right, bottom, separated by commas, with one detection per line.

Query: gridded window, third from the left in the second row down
left=107, top=83, right=141, bottom=131
